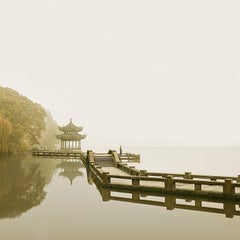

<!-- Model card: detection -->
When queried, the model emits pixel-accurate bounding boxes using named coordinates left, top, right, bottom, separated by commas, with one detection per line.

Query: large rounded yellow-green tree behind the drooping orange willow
left=0, top=87, right=46, bottom=152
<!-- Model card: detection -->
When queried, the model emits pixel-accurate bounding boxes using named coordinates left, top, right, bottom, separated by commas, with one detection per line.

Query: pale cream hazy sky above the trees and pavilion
left=0, top=0, right=240, bottom=147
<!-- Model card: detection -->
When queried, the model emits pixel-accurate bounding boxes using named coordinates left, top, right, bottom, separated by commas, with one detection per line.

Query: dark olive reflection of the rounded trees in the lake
left=0, top=155, right=46, bottom=218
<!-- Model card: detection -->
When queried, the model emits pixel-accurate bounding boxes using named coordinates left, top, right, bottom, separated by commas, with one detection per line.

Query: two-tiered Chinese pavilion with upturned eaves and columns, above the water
left=56, top=119, right=86, bottom=150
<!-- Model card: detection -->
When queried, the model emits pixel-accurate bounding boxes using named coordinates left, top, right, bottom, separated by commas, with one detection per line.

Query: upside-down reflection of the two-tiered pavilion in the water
left=56, top=159, right=84, bottom=185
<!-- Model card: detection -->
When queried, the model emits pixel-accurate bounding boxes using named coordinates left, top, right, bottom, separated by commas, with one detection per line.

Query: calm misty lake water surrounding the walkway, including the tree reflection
left=0, top=148, right=240, bottom=240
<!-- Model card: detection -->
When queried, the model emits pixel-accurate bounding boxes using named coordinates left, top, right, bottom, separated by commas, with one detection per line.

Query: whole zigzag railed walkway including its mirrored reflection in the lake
left=33, top=150, right=240, bottom=218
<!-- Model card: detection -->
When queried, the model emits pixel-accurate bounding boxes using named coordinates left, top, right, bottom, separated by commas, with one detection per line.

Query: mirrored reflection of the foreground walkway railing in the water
left=95, top=185, right=240, bottom=218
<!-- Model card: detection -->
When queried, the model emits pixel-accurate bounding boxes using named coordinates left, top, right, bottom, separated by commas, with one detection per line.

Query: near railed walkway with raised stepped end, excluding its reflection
left=79, top=151, right=240, bottom=201
